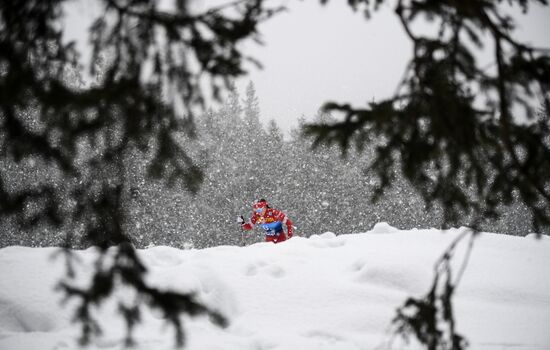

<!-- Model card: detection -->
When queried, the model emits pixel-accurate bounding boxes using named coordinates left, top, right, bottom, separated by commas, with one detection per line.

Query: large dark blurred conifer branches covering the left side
left=0, top=0, right=279, bottom=344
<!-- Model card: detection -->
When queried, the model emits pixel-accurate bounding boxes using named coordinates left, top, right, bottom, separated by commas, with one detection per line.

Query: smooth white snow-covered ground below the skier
left=0, top=224, right=550, bottom=350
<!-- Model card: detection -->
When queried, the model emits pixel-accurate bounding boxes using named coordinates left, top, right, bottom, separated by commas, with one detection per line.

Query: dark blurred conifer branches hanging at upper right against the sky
left=306, top=0, right=550, bottom=231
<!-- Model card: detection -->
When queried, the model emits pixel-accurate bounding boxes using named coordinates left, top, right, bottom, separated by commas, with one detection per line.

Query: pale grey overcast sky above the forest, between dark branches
left=64, top=0, right=550, bottom=135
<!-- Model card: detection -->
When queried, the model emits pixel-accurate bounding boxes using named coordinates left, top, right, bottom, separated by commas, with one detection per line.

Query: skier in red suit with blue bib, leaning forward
left=237, top=199, right=293, bottom=243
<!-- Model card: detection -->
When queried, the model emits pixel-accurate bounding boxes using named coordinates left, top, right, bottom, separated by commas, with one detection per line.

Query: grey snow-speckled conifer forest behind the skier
left=0, top=82, right=548, bottom=248
